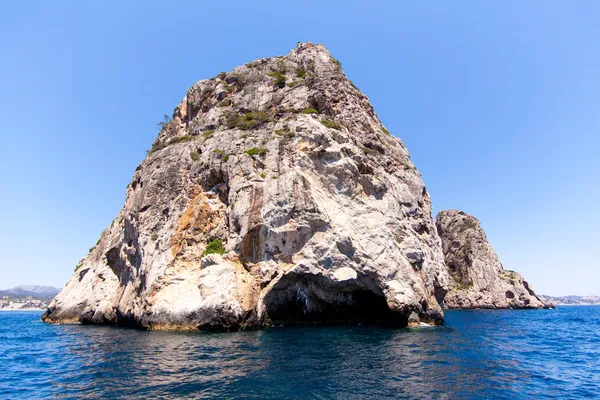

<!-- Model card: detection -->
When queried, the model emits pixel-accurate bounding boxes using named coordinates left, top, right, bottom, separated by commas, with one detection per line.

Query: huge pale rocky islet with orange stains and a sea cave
left=43, top=43, right=450, bottom=330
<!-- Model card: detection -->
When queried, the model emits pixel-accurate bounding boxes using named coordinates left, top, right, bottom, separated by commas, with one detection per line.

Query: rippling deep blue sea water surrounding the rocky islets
left=0, top=306, right=600, bottom=399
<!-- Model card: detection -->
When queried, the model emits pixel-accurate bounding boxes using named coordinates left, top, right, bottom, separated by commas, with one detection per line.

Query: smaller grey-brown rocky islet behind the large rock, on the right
left=436, top=210, right=550, bottom=308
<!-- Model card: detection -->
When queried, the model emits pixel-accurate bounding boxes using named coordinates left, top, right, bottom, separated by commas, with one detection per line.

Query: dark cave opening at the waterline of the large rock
left=265, top=274, right=408, bottom=327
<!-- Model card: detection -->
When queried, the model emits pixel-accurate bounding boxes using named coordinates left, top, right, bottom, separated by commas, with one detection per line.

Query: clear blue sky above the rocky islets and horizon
left=0, top=0, right=600, bottom=295
